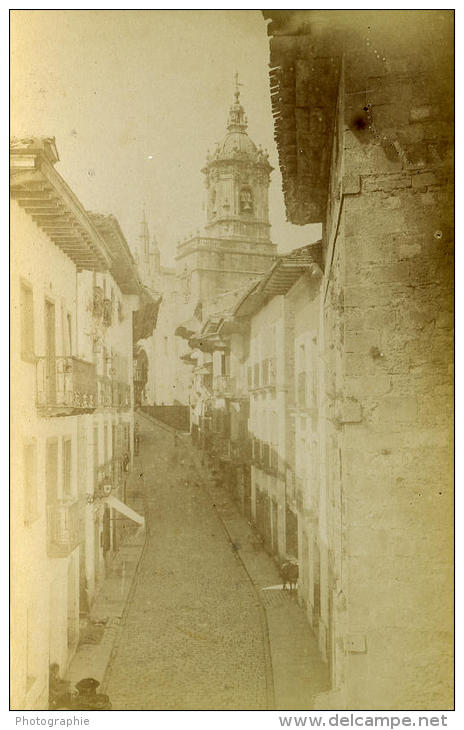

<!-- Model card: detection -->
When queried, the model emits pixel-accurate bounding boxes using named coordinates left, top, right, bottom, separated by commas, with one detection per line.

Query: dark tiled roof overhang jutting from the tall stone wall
left=262, top=10, right=342, bottom=225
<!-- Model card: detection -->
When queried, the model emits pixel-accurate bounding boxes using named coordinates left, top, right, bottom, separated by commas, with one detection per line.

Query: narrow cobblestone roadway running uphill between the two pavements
left=105, top=419, right=268, bottom=710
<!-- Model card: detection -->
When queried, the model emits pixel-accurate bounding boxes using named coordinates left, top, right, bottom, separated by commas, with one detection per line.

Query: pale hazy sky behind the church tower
left=11, top=10, right=320, bottom=265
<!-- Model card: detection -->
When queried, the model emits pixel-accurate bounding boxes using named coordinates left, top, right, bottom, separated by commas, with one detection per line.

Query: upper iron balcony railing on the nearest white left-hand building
left=37, top=355, right=97, bottom=415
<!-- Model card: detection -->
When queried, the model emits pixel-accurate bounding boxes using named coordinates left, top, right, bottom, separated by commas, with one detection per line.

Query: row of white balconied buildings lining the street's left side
left=11, top=139, right=148, bottom=709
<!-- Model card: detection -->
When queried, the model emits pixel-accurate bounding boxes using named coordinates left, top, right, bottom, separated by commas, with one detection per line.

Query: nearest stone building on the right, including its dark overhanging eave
left=264, top=10, right=453, bottom=710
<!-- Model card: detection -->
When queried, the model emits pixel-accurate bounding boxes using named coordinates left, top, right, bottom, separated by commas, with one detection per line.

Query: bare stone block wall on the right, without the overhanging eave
left=321, top=27, right=453, bottom=709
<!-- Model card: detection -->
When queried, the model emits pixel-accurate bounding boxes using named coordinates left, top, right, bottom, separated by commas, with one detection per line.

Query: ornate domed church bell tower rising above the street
left=176, top=75, right=277, bottom=309
